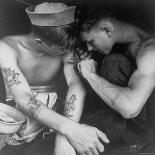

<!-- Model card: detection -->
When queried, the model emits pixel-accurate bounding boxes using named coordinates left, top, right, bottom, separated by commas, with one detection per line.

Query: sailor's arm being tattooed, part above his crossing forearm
left=64, top=53, right=86, bottom=122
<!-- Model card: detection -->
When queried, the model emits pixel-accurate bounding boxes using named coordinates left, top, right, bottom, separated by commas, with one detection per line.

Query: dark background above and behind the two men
left=0, top=0, right=155, bottom=38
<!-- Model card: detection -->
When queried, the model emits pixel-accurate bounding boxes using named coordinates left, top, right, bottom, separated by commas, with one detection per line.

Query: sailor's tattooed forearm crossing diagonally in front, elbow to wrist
left=16, top=93, right=72, bottom=135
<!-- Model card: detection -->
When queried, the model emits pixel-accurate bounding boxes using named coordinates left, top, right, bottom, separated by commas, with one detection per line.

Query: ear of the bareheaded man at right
left=100, top=23, right=113, bottom=38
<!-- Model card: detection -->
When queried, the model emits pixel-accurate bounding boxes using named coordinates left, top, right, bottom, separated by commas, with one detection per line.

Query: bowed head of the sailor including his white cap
left=26, top=2, right=76, bottom=54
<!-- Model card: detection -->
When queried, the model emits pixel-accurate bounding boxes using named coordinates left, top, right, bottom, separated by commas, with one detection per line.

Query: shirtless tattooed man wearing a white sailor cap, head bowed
left=0, top=3, right=109, bottom=155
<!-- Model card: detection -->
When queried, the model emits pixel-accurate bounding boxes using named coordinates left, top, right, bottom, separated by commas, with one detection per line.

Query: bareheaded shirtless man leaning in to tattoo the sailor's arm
left=78, top=6, right=155, bottom=151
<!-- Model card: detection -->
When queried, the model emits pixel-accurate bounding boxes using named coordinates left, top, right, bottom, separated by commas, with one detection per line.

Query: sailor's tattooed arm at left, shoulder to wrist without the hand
left=0, top=42, right=73, bottom=133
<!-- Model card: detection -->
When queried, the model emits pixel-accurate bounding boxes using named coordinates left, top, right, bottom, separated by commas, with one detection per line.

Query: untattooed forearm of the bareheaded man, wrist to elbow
left=86, top=73, right=132, bottom=116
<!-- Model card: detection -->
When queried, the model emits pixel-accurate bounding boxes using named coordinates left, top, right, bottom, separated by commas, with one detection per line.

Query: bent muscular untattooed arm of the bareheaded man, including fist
left=80, top=40, right=155, bottom=118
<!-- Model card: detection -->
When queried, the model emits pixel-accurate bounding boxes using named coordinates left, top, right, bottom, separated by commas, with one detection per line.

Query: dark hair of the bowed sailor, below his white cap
left=31, top=23, right=77, bottom=49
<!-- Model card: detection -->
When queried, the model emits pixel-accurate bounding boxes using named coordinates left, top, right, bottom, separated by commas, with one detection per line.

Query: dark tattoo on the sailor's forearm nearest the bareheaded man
left=64, top=95, right=77, bottom=118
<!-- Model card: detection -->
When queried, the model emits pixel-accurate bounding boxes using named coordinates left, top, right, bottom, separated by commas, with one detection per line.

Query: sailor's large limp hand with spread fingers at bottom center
left=63, top=123, right=109, bottom=155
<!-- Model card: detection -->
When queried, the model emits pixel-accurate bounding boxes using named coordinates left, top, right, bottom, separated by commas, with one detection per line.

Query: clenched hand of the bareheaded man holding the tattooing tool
left=78, top=59, right=97, bottom=78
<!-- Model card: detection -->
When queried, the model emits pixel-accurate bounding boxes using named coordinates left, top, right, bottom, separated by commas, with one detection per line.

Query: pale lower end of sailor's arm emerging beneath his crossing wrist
left=54, top=134, right=76, bottom=155
